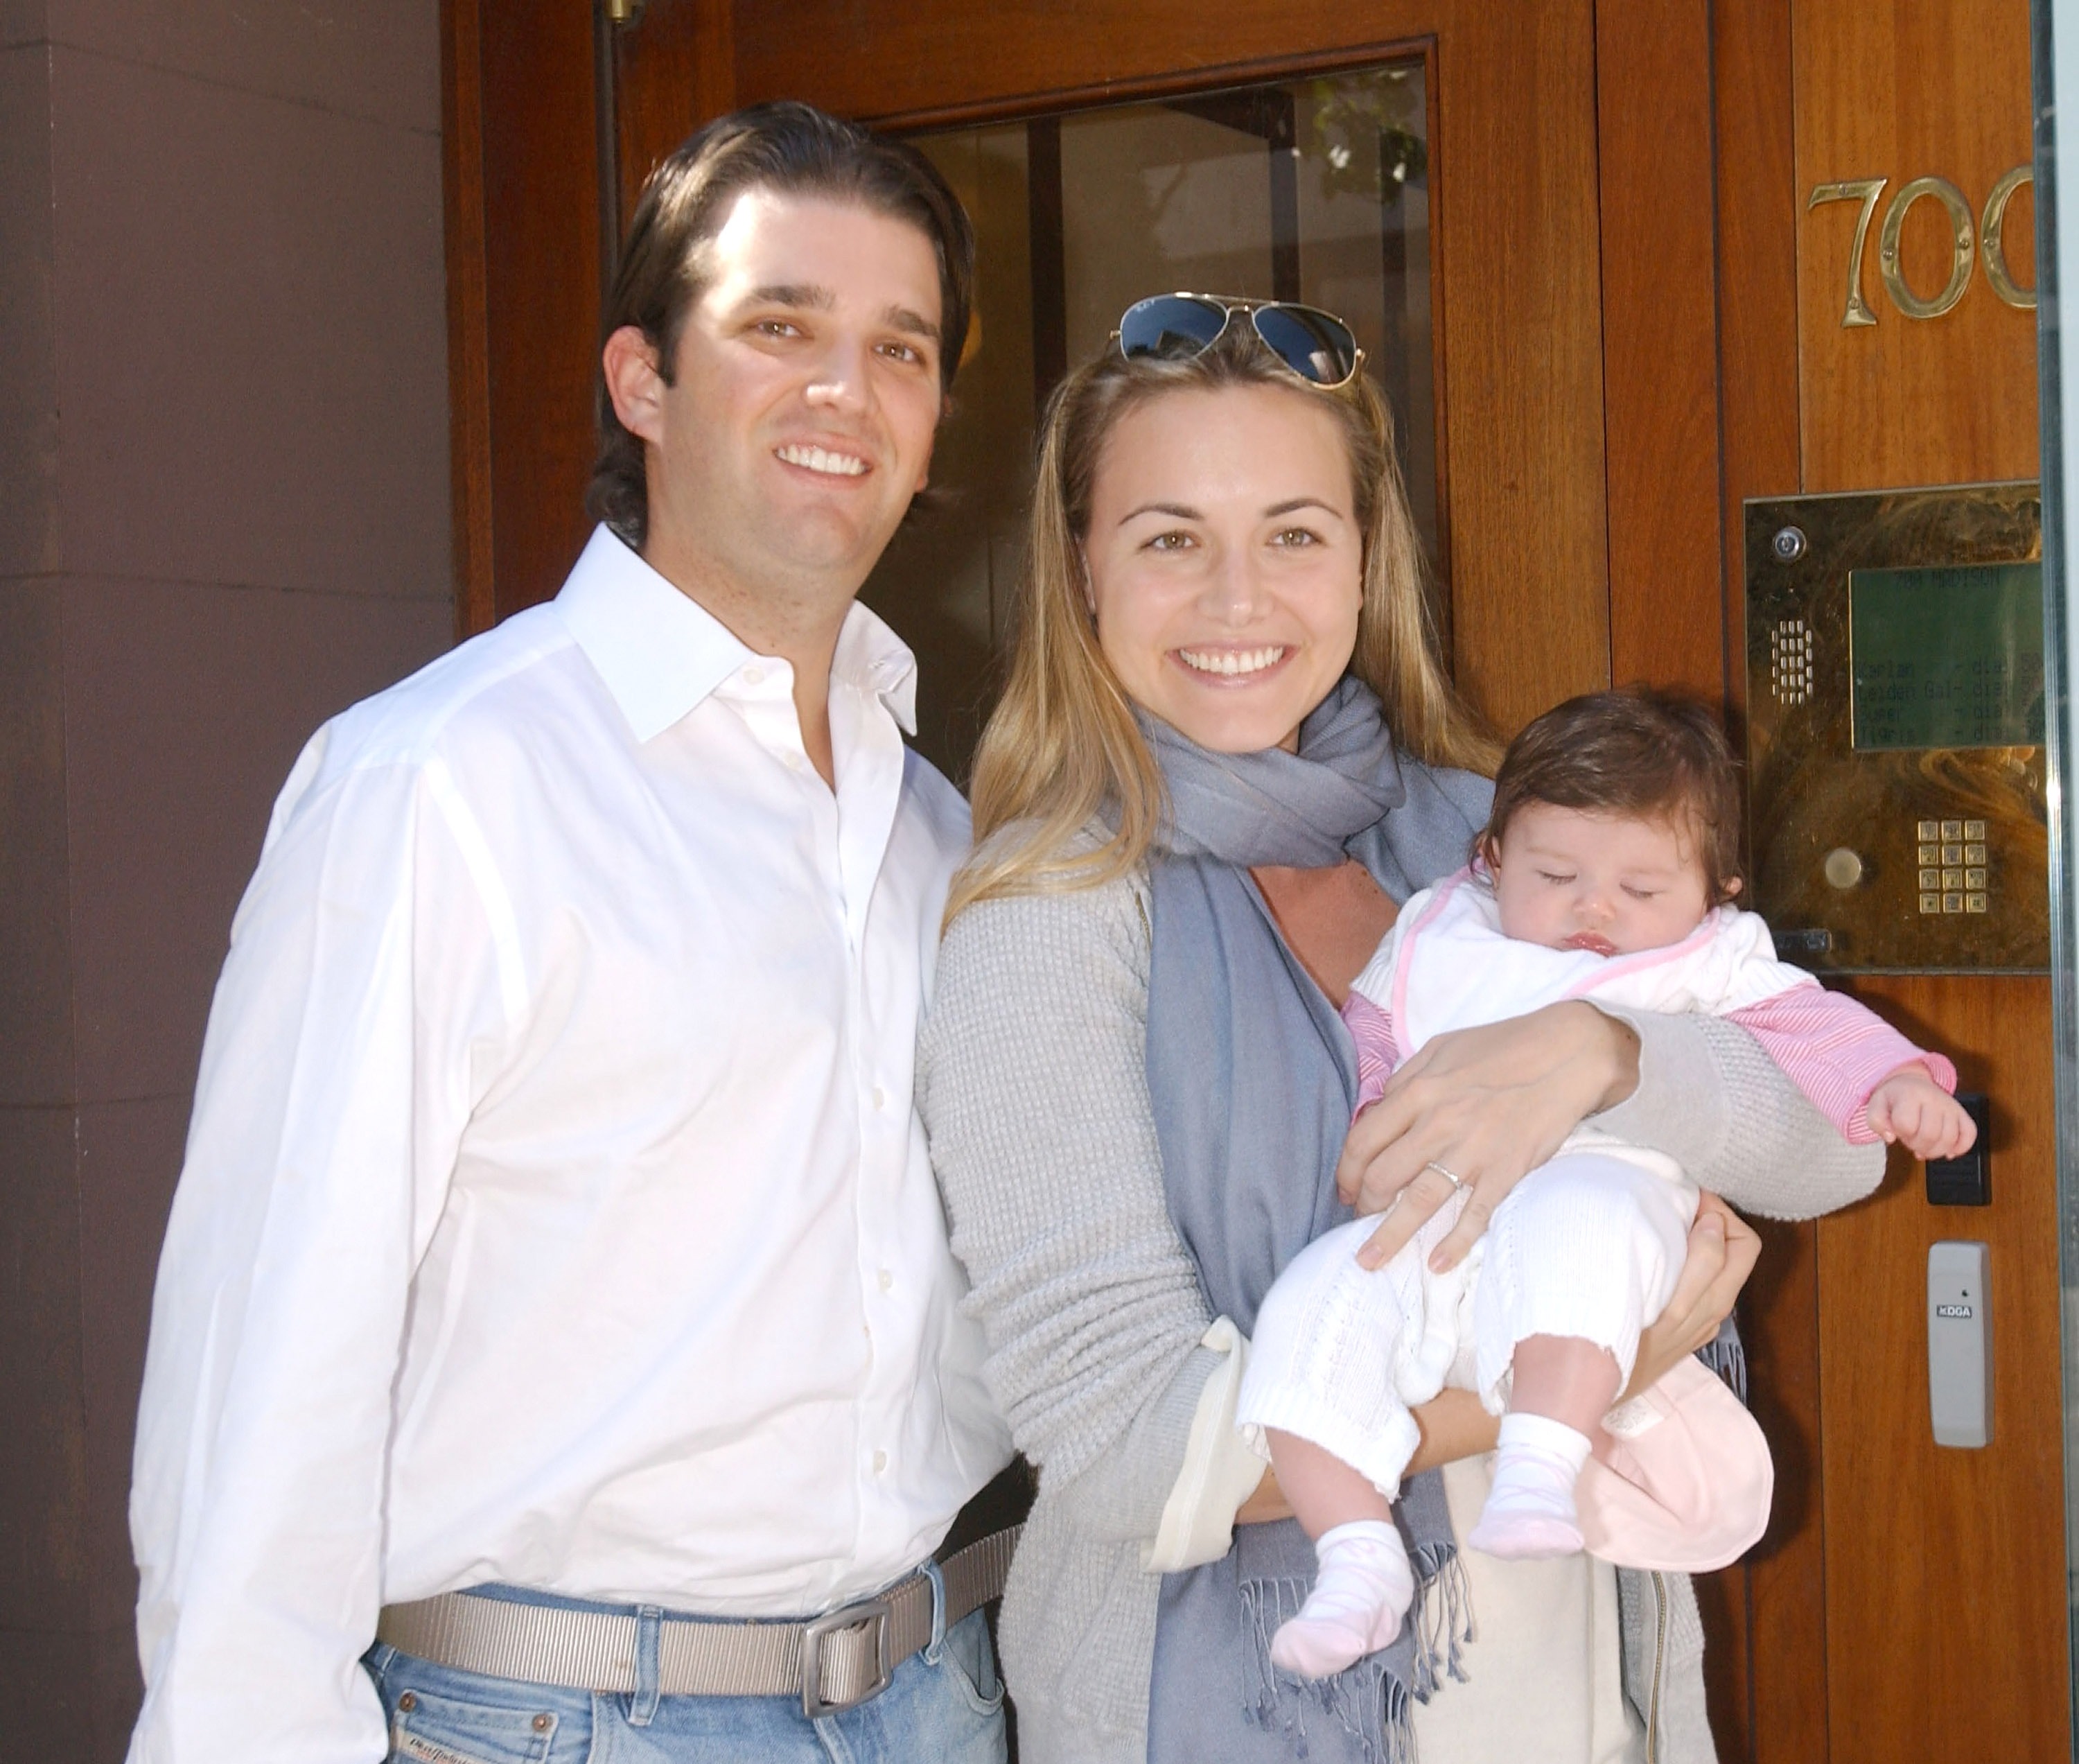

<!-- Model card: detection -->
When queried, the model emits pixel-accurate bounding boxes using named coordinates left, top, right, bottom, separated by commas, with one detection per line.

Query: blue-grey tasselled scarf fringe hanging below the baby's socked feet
left=1241, top=1544, right=1474, bottom=1764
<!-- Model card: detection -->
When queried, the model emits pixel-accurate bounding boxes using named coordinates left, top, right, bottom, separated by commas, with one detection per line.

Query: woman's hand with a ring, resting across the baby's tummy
left=1335, top=1001, right=1638, bottom=1273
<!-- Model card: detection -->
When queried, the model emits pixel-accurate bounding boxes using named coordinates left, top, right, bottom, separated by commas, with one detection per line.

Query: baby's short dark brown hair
left=1474, top=686, right=1740, bottom=907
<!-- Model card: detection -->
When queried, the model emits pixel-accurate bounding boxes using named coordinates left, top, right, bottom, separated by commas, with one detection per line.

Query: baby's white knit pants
left=1235, top=1149, right=1696, bottom=1500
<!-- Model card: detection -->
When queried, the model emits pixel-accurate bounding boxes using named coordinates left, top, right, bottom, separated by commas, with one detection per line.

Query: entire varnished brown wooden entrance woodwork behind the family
left=445, top=0, right=2069, bottom=1764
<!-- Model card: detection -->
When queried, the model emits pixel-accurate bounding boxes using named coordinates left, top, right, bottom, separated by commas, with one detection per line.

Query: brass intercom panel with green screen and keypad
left=1746, top=482, right=2050, bottom=974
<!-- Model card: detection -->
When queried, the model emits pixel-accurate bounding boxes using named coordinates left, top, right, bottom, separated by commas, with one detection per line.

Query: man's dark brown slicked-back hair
left=584, top=102, right=975, bottom=545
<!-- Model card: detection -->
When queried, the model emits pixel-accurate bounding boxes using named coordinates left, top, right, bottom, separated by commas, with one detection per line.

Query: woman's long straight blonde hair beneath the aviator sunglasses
left=946, top=322, right=1499, bottom=922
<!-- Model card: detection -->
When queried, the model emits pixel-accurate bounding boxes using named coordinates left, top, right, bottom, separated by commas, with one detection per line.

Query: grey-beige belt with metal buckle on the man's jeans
left=376, top=1525, right=1023, bottom=1718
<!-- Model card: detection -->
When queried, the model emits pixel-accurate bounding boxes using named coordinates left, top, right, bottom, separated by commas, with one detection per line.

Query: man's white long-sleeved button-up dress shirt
left=131, top=528, right=1010, bottom=1764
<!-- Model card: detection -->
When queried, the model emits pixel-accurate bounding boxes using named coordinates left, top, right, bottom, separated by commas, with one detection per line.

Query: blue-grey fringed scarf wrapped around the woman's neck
left=1141, top=678, right=1491, bottom=1764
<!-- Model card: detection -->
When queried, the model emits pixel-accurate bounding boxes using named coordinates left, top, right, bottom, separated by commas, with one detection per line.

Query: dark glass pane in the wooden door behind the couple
left=865, top=58, right=1449, bottom=778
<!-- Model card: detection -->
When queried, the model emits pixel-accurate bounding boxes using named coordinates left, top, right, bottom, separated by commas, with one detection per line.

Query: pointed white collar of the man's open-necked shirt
left=555, top=526, right=917, bottom=740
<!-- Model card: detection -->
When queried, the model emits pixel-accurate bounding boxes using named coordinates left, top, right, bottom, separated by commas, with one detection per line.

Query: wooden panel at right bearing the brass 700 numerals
left=1713, top=0, right=2071, bottom=1764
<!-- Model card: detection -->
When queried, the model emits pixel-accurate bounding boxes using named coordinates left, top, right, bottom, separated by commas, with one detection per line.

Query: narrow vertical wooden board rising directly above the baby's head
left=1595, top=0, right=1726, bottom=699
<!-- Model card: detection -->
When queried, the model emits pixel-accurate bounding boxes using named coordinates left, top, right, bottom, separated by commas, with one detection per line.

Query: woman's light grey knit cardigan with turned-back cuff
left=917, top=877, right=1884, bottom=1764
